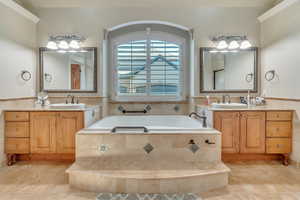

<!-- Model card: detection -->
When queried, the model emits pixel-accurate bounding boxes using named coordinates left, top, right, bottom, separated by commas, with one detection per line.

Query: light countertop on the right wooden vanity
left=197, top=105, right=294, bottom=111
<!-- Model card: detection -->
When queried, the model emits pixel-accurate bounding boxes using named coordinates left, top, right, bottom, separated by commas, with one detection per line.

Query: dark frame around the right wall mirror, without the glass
left=199, top=47, right=258, bottom=93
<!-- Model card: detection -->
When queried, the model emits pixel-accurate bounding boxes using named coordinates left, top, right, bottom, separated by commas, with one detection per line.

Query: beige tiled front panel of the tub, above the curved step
left=76, top=133, right=221, bottom=163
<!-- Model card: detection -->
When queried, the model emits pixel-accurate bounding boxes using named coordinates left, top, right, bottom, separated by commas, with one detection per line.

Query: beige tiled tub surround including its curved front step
left=67, top=130, right=230, bottom=193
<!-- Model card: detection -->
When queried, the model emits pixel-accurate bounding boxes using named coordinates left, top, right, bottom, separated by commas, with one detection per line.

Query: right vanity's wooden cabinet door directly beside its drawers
left=240, top=112, right=266, bottom=153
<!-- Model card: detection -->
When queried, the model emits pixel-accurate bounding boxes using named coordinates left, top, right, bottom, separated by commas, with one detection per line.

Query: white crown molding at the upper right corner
left=257, top=0, right=299, bottom=23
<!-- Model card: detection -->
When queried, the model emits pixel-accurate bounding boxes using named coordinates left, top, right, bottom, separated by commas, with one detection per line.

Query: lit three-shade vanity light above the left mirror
left=47, top=34, right=86, bottom=53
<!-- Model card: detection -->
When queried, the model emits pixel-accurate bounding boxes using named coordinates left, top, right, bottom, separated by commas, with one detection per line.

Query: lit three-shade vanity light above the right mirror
left=212, top=36, right=252, bottom=50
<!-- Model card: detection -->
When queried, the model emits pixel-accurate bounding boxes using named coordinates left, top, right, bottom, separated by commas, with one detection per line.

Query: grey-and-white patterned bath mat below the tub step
left=96, top=193, right=201, bottom=200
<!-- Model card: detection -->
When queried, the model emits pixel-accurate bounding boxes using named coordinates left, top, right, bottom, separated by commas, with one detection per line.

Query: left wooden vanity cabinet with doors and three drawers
left=4, top=107, right=100, bottom=165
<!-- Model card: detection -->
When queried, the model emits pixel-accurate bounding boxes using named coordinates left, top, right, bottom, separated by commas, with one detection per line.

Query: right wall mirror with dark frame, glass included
left=200, top=47, right=258, bottom=93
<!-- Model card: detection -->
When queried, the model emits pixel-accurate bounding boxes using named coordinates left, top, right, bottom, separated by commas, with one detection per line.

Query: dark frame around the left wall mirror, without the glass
left=39, top=47, right=98, bottom=93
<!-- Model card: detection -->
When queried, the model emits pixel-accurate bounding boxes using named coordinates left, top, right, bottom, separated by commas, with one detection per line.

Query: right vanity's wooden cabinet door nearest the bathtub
left=214, top=112, right=240, bottom=153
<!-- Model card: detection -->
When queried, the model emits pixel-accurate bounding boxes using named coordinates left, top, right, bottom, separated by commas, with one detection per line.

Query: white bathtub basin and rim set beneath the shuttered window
left=85, top=115, right=213, bottom=134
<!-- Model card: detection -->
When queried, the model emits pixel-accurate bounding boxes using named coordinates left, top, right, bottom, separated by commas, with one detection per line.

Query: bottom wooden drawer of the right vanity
left=266, top=138, right=291, bottom=154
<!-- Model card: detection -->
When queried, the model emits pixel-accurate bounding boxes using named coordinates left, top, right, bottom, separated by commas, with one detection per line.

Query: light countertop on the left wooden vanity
left=0, top=104, right=100, bottom=112
